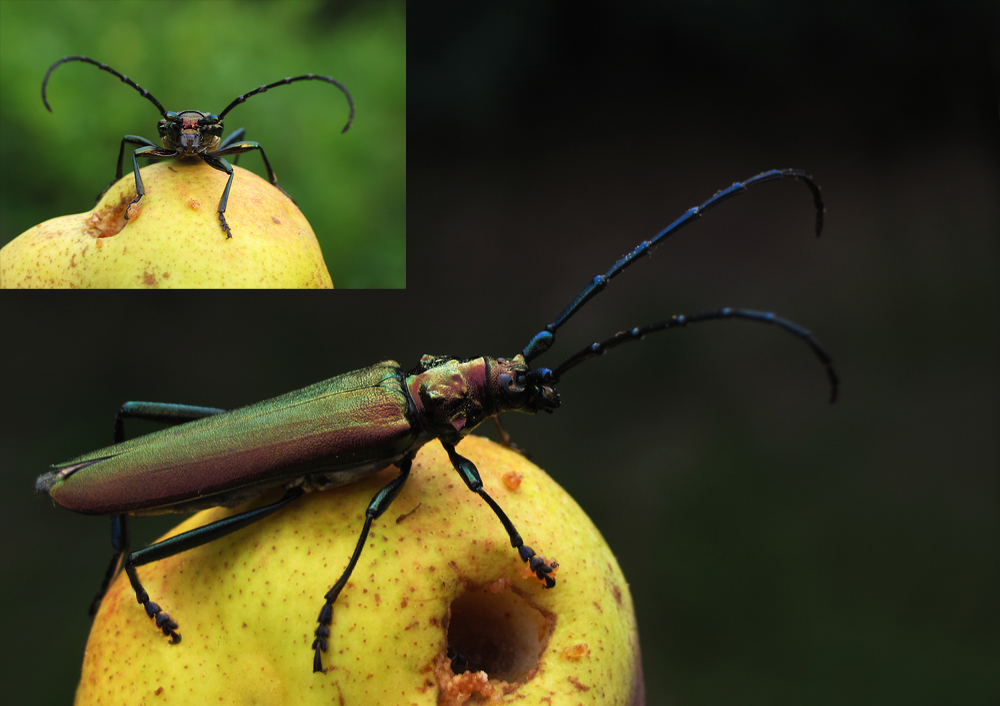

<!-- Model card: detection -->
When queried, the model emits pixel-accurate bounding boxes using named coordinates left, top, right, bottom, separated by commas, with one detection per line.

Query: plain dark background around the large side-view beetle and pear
left=0, top=1, right=1000, bottom=705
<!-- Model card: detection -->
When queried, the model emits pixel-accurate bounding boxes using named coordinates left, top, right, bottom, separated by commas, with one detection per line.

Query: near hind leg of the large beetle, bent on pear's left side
left=125, top=487, right=305, bottom=643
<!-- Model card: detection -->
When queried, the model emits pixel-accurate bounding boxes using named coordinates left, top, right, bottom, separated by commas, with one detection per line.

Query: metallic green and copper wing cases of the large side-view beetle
left=36, top=361, right=422, bottom=514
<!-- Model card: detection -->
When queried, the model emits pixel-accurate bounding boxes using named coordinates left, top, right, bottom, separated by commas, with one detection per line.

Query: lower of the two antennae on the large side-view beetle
left=552, top=307, right=840, bottom=404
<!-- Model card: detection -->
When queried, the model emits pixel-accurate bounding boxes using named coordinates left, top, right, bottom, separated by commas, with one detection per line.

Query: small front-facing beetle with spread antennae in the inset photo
left=42, top=56, right=354, bottom=240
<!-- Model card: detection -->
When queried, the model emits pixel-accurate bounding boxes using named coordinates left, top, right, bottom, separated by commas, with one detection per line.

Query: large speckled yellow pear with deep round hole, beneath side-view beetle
left=76, top=434, right=644, bottom=706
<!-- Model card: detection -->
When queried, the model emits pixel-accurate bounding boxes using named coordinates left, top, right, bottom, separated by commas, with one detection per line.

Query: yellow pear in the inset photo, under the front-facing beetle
left=0, top=159, right=333, bottom=288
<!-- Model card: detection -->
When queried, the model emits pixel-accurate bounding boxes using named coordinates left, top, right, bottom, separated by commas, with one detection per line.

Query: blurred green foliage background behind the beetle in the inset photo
left=0, top=0, right=406, bottom=288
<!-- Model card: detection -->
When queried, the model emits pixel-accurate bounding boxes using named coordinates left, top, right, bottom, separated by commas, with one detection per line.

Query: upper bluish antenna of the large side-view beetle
left=521, top=169, right=826, bottom=362
